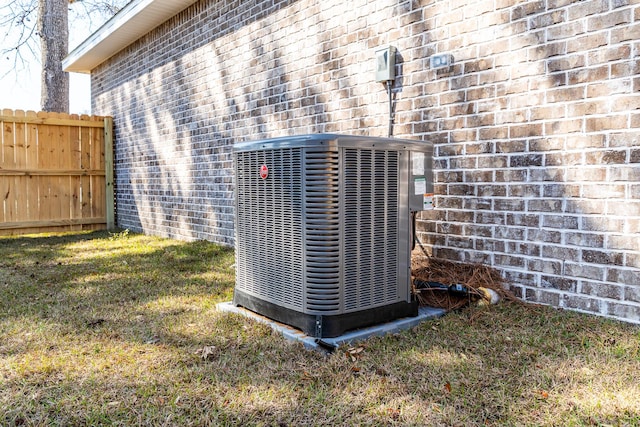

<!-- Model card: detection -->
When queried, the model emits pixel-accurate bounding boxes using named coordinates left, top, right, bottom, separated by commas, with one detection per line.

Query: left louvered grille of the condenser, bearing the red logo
left=236, top=148, right=304, bottom=310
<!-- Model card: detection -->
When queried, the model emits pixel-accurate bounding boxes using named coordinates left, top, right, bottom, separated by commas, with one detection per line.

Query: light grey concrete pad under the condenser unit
left=217, top=302, right=446, bottom=350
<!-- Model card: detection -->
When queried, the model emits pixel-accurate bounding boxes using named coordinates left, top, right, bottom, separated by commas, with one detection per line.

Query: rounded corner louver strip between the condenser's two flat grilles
left=304, top=151, right=341, bottom=314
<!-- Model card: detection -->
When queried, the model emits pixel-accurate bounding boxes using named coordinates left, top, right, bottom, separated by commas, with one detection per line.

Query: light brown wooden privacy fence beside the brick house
left=0, top=110, right=115, bottom=235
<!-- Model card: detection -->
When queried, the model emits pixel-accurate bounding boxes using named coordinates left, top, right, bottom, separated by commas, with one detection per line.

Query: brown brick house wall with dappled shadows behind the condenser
left=92, top=0, right=640, bottom=323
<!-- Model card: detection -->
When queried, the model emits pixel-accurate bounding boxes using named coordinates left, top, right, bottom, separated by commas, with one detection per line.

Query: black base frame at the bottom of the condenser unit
left=233, top=290, right=418, bottom=338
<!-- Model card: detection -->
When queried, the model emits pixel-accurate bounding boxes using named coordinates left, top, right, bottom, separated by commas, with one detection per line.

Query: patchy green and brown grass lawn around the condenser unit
left=0, top=232, right=640, bottom=426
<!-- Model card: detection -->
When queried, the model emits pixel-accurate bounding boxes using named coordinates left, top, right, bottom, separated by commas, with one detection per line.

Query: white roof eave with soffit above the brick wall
left=62, top=0, right=197, bottom=73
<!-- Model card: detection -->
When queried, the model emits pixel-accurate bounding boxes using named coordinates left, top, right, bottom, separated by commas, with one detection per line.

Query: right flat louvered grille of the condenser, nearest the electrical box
left=343, top=149, right=398, bottom=311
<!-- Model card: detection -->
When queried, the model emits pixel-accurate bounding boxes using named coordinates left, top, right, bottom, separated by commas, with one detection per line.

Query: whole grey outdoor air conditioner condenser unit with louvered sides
left=234, top=134, right=433, bottom=337
